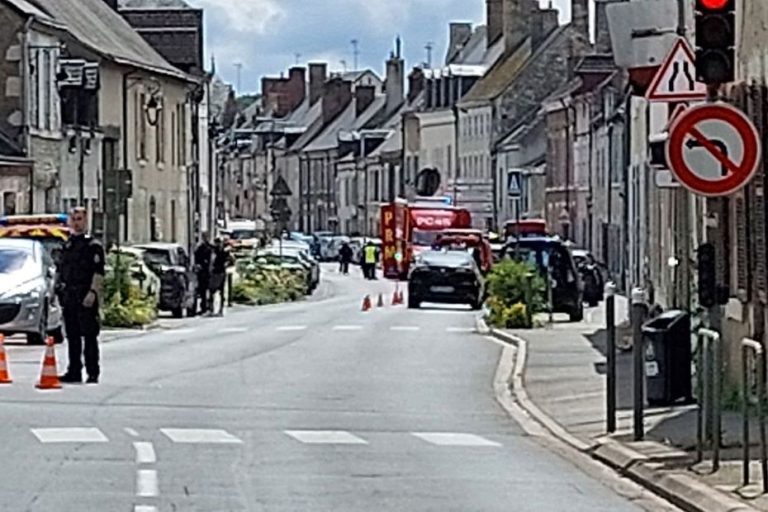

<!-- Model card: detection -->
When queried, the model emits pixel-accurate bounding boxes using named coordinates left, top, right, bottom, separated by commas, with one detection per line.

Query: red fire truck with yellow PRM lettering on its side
left=381, top=199, right=472, bottom=279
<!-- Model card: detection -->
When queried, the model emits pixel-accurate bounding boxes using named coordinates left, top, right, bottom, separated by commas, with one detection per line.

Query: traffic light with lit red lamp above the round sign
left=696, top=0, right=736, bottom=85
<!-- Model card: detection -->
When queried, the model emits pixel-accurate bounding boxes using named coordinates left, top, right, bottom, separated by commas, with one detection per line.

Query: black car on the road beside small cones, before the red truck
left=408, top=251, right=485, bottom=309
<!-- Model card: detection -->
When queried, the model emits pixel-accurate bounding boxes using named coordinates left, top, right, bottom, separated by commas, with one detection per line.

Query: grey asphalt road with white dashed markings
left=0, top=266, right=672, bottom=512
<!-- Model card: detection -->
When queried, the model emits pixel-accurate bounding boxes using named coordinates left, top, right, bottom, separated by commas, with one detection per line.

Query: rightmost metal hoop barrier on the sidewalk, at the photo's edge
left=741, top=338, right=768, bottom=493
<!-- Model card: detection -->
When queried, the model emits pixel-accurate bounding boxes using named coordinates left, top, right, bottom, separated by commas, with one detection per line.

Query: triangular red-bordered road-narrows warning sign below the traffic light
left=645, top=37, right=707, bottom=101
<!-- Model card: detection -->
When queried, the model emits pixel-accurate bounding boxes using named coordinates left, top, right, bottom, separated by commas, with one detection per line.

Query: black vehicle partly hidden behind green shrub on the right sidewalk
left=504, top=236, right=584, bottom=322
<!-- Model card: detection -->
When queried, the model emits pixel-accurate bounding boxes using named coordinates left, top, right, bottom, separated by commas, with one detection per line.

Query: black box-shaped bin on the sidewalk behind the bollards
left=643, top=310, right=692, bottom=405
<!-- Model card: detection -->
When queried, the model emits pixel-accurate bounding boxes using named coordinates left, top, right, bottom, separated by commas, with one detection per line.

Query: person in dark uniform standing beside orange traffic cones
left=59, top=207, right=104, bottom=384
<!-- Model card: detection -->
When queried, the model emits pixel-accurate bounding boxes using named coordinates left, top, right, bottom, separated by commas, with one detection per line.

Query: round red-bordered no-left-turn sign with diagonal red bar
left=667, top=103, right=761, bottom=197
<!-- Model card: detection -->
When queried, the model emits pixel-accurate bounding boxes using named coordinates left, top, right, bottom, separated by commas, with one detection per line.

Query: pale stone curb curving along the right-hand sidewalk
left=486, top=326, right=760, bottom=512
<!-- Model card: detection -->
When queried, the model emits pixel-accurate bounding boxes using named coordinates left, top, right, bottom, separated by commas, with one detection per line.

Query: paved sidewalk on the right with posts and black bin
left=495, top=298, right=768, bottom=511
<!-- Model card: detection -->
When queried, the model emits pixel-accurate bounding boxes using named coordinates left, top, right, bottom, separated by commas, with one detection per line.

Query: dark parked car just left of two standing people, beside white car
left=134, top=242, right=197, bottom=318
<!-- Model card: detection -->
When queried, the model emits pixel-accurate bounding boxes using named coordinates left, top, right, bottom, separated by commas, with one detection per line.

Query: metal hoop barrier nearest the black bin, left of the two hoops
left=696, top=329, right=722, bottom=472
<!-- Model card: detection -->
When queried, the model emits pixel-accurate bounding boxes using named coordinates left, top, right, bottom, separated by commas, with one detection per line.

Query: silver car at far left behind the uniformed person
left=0, top=238, right=63, bottom=344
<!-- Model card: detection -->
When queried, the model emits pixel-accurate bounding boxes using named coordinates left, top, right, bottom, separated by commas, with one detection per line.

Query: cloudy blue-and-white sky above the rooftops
left=187, top=0, right=570, bottom=92
